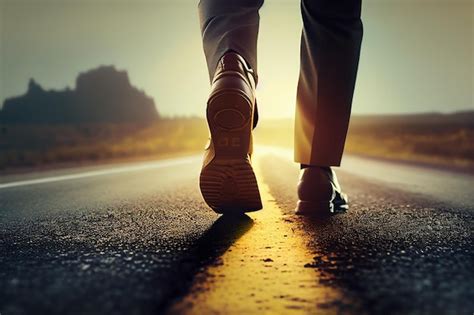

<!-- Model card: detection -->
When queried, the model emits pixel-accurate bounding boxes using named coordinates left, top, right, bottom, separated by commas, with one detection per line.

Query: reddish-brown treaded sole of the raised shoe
left=199, top=91, right=262, bottom=214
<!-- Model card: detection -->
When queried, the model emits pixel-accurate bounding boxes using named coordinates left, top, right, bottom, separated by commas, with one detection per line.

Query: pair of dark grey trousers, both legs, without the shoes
left=199, top=0, right=362, bottom=166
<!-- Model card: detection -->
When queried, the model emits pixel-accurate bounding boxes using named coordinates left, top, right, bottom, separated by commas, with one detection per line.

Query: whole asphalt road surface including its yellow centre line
left=0, top=148, right=474, bottom=315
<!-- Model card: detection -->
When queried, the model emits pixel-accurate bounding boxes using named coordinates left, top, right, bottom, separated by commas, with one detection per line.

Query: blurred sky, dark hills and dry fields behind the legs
left=0, top=0, right=474, bottom=173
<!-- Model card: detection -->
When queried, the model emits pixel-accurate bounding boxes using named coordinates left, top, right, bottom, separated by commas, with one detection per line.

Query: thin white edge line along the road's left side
left=0, top=155, right=201, bottom=189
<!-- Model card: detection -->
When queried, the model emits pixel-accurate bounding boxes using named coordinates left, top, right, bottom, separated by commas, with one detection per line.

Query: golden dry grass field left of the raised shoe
left=0, top=118, right=208, bottom=169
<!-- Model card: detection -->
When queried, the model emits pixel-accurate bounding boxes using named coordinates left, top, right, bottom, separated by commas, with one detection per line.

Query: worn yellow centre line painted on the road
left=170, top=160, right=340, bottom=315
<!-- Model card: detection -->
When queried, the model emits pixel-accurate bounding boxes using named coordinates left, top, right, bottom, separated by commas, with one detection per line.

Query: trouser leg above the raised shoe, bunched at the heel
left=198, top=0, right=263, bottom=81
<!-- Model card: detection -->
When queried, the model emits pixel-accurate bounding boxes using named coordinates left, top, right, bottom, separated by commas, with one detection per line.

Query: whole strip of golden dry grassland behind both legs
left=0, top=112, right=474, bottom=172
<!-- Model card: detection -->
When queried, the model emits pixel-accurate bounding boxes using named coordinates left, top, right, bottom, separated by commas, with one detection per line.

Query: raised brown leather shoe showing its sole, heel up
left=199, top=52, right=262, bottom=214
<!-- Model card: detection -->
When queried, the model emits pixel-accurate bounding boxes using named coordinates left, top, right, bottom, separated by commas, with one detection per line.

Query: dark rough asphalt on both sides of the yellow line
left=0, top=152, right=474, bottom=315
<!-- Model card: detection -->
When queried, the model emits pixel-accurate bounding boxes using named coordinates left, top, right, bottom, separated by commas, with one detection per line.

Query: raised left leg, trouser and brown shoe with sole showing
left=199, top=0, right=263, bottom=214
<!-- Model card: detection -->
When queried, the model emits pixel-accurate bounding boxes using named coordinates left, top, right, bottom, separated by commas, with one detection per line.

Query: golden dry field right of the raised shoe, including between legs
left=256, top=112, right=474, bottom=172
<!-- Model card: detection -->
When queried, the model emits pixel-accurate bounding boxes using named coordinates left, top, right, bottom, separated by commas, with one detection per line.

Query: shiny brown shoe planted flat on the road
left=295, top=166, right=349, bottom=216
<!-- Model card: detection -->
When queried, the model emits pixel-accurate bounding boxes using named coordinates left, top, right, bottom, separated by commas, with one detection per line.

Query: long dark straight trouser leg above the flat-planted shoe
left=295, top=0, right=362, bottom=166
